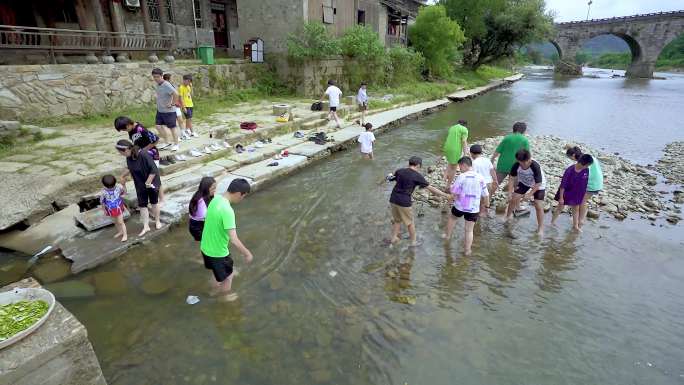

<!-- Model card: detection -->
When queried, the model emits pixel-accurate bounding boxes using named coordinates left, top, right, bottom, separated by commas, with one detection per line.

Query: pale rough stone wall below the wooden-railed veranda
left=0, top=61, right=266, bottom=121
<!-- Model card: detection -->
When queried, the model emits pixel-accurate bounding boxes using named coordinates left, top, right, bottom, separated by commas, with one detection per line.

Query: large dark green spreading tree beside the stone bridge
left=439, top=0, right=553, bottom=68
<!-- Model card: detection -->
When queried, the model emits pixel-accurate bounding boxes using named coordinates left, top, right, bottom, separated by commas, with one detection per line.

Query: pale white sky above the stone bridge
left=546, top=0, right=684, bottom=22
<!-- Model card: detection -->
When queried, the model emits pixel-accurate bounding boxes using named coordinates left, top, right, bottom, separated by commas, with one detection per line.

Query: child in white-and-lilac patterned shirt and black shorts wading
left=443, top=156, right=486, bottom=255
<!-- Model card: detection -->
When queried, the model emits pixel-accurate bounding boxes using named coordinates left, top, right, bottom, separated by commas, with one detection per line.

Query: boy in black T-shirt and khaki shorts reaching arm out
left=387, top=156, right=451, bottom=246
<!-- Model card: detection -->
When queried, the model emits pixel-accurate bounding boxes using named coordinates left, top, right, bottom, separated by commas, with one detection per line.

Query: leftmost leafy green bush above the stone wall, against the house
left=287, top=21, right=340, bottom=61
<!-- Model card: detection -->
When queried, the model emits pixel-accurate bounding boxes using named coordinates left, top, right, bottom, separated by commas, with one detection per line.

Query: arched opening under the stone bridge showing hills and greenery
left=575, top=33, right=642, bottom=70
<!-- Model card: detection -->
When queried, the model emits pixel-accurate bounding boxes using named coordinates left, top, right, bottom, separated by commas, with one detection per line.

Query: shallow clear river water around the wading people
left=9, top=69, right=684, bottom=385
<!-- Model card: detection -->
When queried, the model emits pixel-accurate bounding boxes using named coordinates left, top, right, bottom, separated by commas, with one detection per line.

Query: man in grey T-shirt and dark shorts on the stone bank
left=152, top=68, right=180, bottom=151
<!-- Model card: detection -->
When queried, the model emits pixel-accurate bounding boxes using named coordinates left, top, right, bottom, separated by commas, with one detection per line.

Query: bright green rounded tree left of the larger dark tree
left=409, top=5, right=465, bottom=77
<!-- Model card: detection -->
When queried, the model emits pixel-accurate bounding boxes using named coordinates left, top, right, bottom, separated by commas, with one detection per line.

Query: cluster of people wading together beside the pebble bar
left=387, top=120, right=603, bottom=255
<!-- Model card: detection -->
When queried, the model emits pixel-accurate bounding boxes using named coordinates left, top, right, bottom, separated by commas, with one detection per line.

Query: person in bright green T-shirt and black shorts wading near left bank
left=200, top=178, right=253, bottom=301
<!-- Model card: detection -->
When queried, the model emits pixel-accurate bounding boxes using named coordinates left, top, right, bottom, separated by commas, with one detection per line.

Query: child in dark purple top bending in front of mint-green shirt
left=551, top=154, right=594, bottom=231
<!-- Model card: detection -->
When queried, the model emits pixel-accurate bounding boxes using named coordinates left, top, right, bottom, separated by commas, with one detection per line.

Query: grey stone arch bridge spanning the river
left=551, top=10, right=684, bottom=78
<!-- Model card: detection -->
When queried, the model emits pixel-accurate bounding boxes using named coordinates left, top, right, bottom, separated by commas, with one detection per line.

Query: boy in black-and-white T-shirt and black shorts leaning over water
left=506, top=149, right=546, bottom=235
